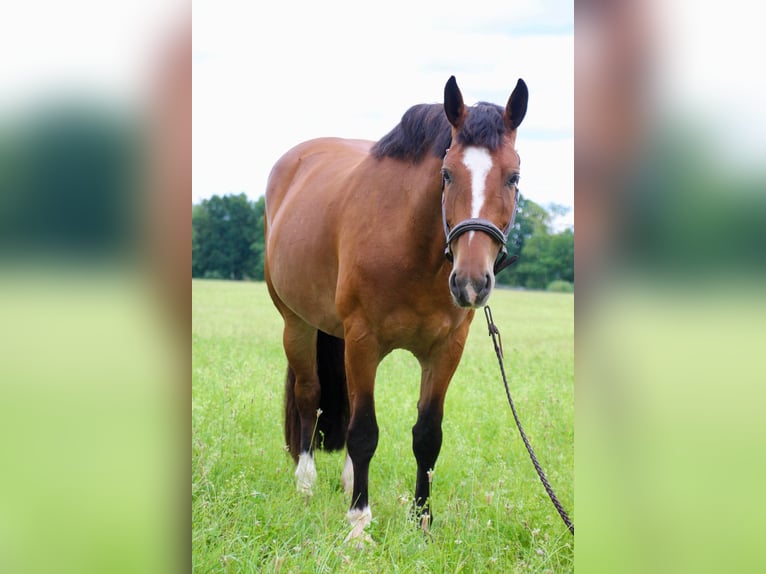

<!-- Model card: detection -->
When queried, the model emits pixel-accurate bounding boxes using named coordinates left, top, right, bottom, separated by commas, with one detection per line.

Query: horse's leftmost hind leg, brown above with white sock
left=283, top=312, right=321, bottom=495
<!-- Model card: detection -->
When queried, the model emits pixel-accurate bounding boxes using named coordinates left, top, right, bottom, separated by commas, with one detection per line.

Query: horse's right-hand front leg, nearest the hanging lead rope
left=412, top=327, right=468, bottom=528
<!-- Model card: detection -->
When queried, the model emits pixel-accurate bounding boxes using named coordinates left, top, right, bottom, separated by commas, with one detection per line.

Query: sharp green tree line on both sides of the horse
left=192, top=193, right=574, bottom=290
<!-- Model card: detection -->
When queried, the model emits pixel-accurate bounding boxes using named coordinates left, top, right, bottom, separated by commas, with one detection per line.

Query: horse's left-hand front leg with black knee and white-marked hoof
left=346, top=329, right=380, bottom=540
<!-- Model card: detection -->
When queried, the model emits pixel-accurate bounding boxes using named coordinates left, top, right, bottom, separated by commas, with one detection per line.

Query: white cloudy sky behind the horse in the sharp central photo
left=192, top=0, right=574, bottom=227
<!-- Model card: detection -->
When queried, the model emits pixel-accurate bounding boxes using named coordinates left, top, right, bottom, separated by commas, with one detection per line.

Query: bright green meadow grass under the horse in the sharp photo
left=192, top=281, right=575, bottom=573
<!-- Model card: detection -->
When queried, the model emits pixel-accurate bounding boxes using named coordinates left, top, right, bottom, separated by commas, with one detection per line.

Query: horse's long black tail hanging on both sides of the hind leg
left=285, top=331, right=349, bottom=462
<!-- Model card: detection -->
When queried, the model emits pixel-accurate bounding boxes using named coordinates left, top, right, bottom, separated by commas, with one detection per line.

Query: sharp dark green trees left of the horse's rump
left=192, top=193, right=265, bottom=279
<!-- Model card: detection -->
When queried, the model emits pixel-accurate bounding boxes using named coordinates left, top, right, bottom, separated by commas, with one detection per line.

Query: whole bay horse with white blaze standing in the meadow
left=264, top=76, right=528, bottom=540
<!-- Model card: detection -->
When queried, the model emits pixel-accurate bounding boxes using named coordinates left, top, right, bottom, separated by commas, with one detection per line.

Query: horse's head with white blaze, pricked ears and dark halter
left=442, top=76, right=528, bottom=308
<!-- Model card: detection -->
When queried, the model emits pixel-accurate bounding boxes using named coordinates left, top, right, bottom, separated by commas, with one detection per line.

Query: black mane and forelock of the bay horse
left=372, top=102, right=506, bottom=163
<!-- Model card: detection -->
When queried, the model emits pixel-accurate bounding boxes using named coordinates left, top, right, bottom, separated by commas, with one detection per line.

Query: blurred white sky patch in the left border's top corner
left=0, top=0, right=184, bottom=110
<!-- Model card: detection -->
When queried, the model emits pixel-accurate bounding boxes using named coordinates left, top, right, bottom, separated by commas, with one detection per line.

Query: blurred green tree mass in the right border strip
left=620, top=127, right=766, bottom=281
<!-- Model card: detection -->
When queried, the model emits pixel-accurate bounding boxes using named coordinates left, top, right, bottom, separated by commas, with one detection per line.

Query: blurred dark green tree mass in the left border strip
left=0, top=103, right=141, bottom=258
